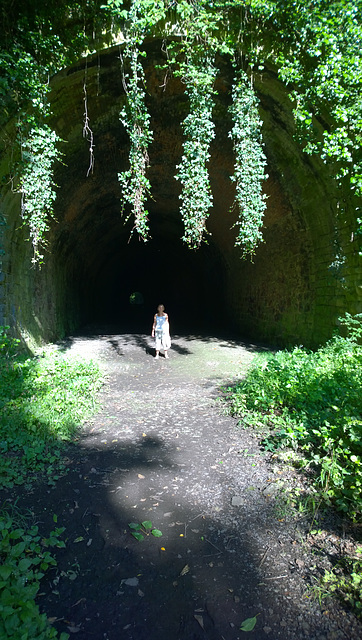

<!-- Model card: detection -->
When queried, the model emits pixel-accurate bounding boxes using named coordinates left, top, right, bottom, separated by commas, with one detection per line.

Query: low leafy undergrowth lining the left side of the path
left=0, top=327, right=101, bottom=640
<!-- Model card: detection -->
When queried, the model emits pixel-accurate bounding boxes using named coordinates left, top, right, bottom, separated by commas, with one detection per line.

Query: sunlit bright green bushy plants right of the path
left=226, top=315, right=362, bottom=516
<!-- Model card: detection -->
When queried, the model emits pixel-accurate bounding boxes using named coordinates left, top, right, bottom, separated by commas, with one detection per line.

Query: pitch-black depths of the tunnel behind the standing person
left=78, top=218, right=227, bottom=333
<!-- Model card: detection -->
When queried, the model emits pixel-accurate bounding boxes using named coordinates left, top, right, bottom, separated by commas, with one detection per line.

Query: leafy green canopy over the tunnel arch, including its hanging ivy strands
left=0, top=0, right=362, bottom=255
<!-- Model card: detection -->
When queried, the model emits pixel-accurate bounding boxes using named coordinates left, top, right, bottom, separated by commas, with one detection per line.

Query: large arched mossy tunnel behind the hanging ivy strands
left=0, top=40, right=362, bottom=346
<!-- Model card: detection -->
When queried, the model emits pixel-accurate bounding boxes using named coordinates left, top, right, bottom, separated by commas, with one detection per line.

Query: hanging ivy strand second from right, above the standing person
left=175, top=50, right=216, bottom=249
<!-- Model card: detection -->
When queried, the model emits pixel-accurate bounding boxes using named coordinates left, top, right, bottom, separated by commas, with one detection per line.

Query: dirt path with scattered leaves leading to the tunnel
left=10, top=334, right=362, bottom=640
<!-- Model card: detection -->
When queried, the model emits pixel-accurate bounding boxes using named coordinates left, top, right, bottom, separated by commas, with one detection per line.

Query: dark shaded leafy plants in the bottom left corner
left=0, top=507, right=69, bottom=640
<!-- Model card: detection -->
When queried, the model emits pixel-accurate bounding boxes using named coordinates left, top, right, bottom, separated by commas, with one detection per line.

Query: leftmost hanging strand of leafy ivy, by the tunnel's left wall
left=19, top=125, right=60, bottom=264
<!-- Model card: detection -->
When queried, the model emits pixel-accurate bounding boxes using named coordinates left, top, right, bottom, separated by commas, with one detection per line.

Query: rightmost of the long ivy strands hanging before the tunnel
left=229, top=72, right=267, bottom=256
